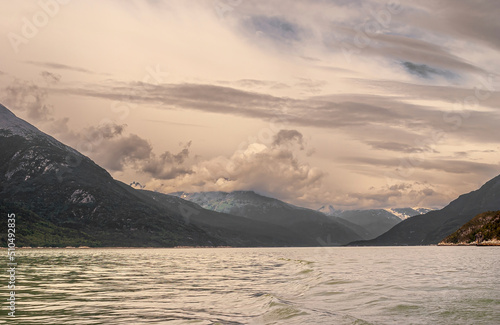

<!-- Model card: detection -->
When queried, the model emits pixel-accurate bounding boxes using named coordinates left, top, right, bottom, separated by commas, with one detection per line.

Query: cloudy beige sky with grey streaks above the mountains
left=0, top=0, right=500, bottom=209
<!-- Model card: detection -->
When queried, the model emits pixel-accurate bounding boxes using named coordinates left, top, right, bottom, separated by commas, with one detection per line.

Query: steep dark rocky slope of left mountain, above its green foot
left=0, top=105, right=221, bottom=246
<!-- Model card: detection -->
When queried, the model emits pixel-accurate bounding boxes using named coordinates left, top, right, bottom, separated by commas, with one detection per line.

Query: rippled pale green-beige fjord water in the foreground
left=4, top=246, right=500, bottom=325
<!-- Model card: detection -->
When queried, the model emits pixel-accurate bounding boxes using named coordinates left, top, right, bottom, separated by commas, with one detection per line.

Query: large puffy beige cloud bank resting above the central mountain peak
left=147, top=130, right=326, bottom=204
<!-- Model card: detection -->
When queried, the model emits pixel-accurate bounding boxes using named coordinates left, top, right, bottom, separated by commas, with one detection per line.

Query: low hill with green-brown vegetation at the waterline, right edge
left=441, top=211, right=500, bottom=244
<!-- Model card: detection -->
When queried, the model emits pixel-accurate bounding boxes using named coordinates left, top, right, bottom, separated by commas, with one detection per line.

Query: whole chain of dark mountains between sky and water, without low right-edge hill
left=0, top=105, right=500, bottom=246
